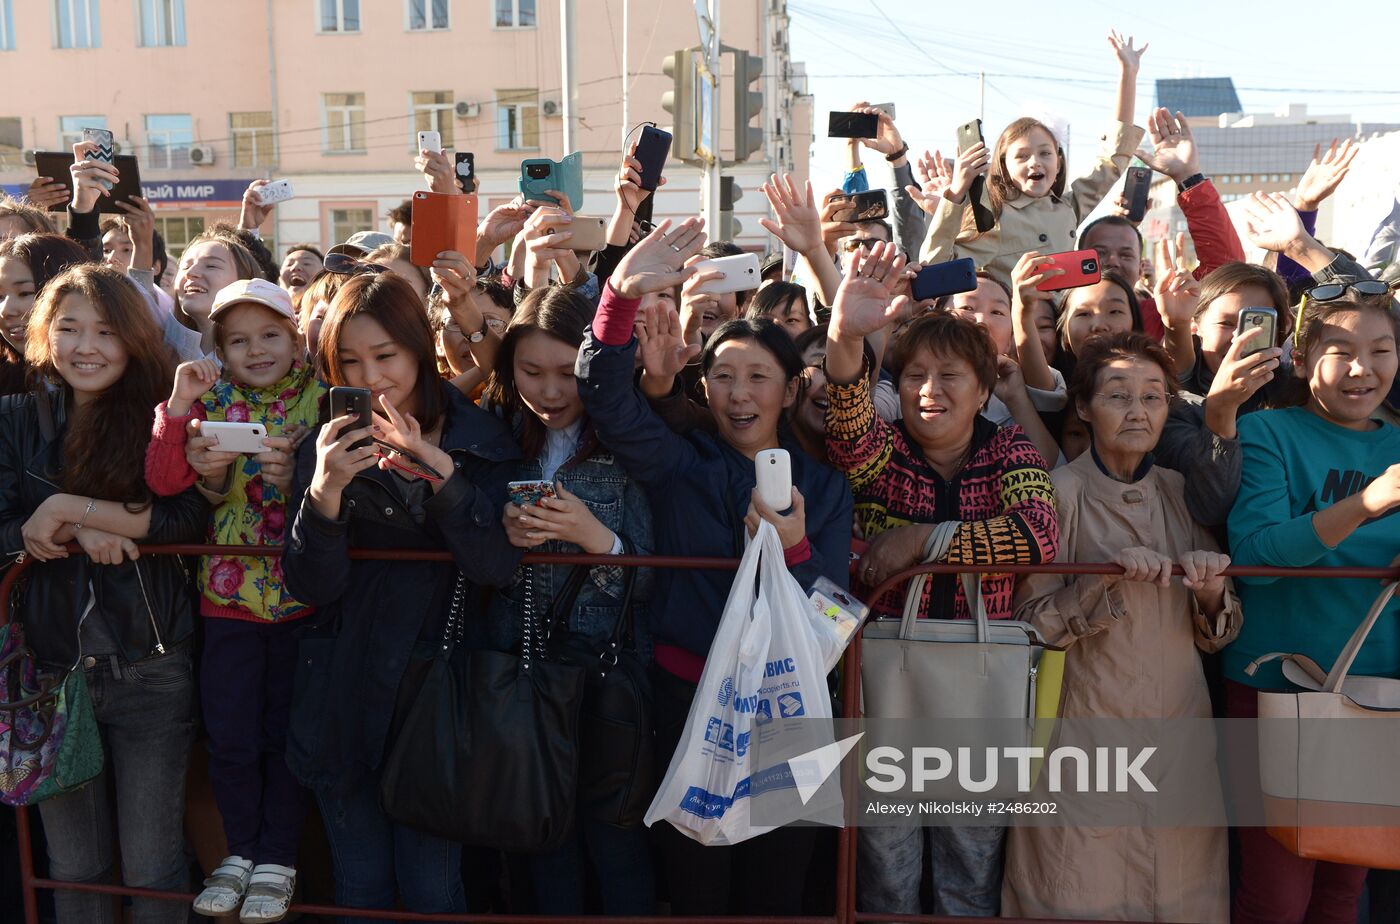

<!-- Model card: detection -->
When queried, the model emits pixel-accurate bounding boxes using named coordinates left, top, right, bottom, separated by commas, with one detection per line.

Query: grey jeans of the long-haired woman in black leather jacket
left=39, top=651, right=195, bottom=924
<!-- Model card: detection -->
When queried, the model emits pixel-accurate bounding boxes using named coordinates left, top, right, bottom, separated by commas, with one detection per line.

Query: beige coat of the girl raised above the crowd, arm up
left=918, top=122, right=1142, bottom=286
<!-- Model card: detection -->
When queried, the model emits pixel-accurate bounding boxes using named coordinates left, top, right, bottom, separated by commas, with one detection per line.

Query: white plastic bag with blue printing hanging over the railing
left=645, top=521, right=844, bottom=844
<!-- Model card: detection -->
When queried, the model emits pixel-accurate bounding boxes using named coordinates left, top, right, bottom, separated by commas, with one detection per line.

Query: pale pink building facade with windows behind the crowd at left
left=0, top=0, right=811, bottom=253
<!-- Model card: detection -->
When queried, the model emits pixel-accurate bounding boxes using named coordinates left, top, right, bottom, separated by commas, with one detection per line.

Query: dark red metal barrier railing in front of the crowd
left=0, top=543, right=1383, bottom=924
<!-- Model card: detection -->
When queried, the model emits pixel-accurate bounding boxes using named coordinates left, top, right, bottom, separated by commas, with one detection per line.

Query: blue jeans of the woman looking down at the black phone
left=316, top=777, right=466, bottom=924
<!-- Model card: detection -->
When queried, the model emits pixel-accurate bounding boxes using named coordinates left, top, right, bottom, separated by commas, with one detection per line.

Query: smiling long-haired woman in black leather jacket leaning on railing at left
left=0, top=263, right=209, bottom=924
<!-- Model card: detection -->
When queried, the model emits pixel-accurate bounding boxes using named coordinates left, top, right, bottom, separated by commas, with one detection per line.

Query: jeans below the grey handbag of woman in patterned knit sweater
left=855, top=826, right=1007, bottom=917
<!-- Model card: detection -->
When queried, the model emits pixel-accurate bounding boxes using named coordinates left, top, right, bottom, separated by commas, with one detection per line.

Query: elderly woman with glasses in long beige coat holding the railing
left=1001, top=333, right=1240, bottom=923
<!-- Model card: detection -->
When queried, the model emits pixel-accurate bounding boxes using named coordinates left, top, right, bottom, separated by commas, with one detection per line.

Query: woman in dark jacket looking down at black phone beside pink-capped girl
left=283, top=273, right=521, bottom=913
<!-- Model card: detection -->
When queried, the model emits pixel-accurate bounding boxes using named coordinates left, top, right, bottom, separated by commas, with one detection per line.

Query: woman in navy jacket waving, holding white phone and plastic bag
left=578, top=218, right=851, bottom=916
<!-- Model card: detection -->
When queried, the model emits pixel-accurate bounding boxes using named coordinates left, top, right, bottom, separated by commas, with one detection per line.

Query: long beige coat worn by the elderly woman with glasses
left=1001, top=452, right=1240, bottom=924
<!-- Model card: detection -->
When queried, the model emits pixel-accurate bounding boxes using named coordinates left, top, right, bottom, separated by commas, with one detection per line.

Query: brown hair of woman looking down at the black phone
left=316, top=273, right=447, bottom=433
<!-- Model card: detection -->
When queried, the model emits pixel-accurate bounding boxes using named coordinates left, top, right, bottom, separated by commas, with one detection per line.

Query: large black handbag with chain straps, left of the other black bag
left=379, top=574, right=584, bottom=853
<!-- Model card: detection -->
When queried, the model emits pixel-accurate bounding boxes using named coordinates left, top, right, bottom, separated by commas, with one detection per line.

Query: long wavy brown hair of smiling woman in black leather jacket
left=25, top=263, right=175, bottom=508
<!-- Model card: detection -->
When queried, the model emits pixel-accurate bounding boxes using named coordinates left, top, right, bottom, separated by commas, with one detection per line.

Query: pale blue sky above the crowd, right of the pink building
left=788, top=0, right=1400, bottom=188
